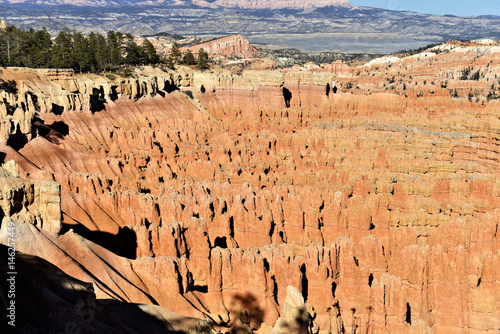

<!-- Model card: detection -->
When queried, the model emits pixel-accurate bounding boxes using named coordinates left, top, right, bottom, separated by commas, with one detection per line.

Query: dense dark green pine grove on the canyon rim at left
left=0, top=26, right=160, bottom=72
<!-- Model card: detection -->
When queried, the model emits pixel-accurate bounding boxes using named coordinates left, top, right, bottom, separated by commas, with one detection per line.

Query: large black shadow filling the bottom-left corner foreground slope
left=0, top=245, right=199, bottom=334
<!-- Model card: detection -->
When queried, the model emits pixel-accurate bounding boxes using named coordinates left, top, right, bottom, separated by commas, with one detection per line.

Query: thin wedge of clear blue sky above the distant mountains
left=349, top=0, right=500, bottom=16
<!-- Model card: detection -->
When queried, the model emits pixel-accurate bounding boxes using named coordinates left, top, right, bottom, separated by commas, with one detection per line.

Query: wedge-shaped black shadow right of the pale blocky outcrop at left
left=61, top=223, right=137, bottom=259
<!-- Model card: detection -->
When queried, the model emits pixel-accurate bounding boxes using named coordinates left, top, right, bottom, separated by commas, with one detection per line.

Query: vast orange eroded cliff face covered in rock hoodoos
left=1, top=45, right=500, bottom=333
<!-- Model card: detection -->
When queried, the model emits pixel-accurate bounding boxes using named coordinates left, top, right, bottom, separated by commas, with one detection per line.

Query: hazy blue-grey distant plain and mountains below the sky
left=0, top=0, right=500, bottom=53
